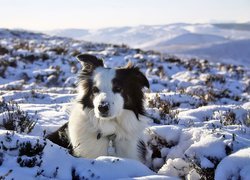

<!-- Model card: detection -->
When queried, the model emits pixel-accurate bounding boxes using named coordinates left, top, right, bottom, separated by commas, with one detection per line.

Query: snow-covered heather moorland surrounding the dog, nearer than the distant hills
left=0, top=28, right=250, bottom=180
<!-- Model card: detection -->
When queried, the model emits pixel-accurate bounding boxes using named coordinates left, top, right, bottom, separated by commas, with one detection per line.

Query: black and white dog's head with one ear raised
left=77, top=54, right=149, bottom=120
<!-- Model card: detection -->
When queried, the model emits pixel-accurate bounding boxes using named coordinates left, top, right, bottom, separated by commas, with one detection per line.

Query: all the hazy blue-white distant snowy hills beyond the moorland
left=46, top=23, right=250, bottom=65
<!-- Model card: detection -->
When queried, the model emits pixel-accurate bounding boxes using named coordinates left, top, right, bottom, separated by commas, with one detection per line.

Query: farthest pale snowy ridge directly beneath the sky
left=45, top=23, right=250, bottom=47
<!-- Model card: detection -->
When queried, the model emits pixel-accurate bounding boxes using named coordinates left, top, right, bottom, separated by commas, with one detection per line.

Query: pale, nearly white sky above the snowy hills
left=0, top=0, right=250, bottom=30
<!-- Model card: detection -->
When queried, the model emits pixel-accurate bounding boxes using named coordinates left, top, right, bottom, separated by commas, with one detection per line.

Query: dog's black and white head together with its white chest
left=68, top=54, right=149, bottom=160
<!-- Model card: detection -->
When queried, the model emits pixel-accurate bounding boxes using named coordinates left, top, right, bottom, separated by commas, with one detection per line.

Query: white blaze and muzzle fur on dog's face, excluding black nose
left=93, top=68, right=124, bottom=119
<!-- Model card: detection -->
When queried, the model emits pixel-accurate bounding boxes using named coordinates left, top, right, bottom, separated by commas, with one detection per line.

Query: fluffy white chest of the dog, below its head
left=69, top=104, right=145, bottom=159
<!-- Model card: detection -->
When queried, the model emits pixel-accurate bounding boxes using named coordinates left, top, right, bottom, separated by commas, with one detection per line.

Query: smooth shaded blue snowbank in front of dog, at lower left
left=0, top=130, right=155, bottom=179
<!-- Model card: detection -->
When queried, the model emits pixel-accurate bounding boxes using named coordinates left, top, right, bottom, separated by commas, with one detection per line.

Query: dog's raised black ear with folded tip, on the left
left=76, top=54, right=103, bottom=73
